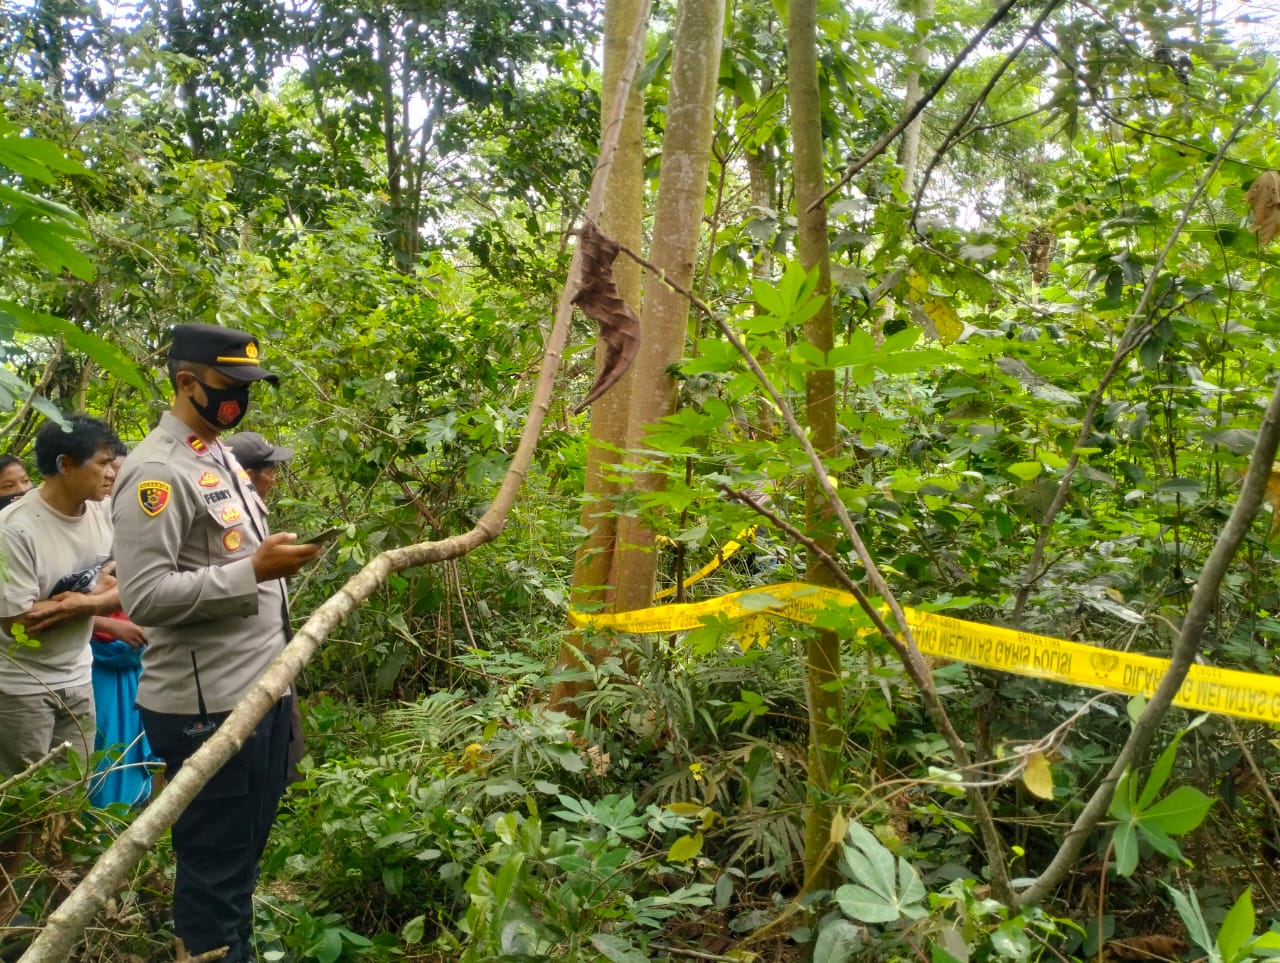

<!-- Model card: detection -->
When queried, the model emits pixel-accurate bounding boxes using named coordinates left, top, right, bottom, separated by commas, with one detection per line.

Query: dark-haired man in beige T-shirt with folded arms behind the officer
left=0, top=415, right=120, bottom=923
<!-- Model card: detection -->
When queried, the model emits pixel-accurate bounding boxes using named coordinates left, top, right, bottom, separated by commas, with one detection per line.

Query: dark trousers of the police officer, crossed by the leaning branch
left=140, top=695, right=293, bottom=963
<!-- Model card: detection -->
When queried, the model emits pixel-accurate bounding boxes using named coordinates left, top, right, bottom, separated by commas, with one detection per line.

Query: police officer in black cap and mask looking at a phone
left=111, top=324, right=320, bottom=963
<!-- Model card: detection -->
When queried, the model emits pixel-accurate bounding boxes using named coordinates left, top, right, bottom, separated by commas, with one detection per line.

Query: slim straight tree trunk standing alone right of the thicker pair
left=787, top=0, right=844, bottom=889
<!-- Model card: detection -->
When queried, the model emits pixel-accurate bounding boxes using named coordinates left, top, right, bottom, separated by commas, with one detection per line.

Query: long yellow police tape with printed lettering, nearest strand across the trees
left=570, top=581, right=1280, bottom=724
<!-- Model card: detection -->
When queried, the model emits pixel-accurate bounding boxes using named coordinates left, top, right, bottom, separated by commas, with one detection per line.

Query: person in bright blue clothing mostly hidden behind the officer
left=90, top=444, right=155, bottom=808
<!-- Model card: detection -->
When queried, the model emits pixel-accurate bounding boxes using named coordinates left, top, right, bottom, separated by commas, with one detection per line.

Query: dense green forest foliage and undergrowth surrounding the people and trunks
left=0, top=0, right=1280, bottom=963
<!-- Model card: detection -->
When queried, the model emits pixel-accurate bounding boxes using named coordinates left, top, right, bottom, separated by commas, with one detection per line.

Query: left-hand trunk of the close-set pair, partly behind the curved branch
left=552, top=0, right=649, bottom=711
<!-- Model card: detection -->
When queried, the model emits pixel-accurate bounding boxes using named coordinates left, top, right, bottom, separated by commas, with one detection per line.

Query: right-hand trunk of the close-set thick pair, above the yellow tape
left=614, top=0, right=724, bottom=611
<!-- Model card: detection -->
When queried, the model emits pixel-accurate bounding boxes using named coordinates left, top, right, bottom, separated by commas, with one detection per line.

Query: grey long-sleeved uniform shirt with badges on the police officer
left=111, top=412, right=288, bottom=715
